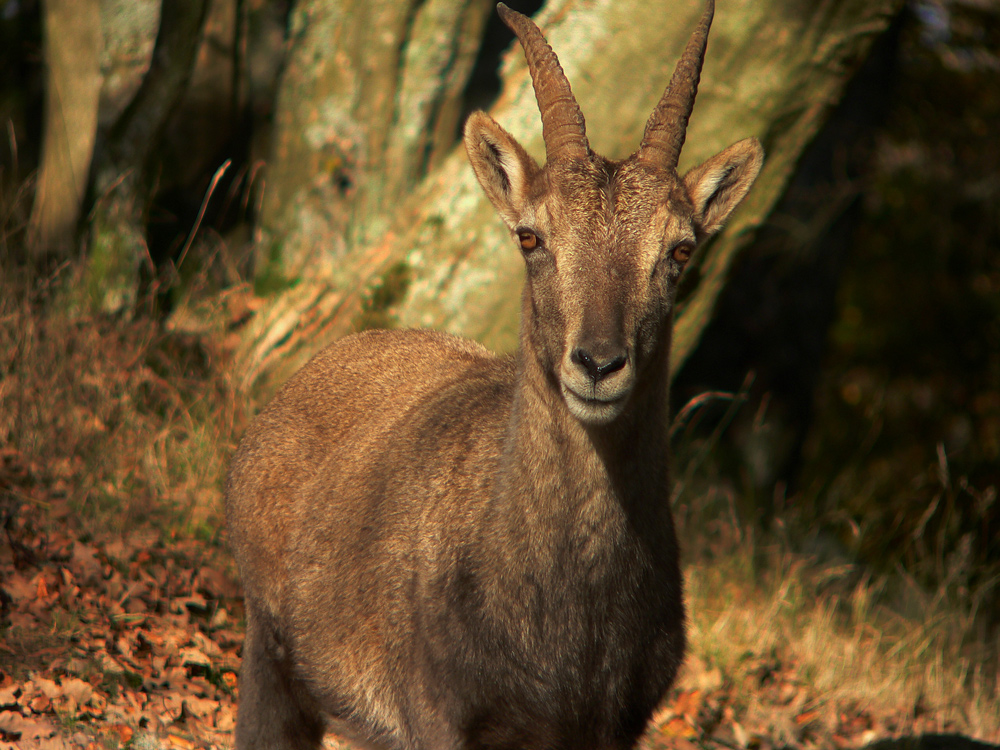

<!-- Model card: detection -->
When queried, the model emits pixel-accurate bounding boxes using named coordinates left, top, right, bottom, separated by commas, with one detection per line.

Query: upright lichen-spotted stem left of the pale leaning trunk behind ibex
left=257, top=0, right=489, bottom=288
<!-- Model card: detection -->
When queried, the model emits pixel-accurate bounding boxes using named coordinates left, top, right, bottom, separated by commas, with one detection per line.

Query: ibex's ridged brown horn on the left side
left=497, top=3, right=590, bottom=162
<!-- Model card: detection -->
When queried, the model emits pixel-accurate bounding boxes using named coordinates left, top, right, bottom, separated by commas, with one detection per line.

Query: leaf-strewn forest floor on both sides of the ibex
left=0, top=458, right=1000, bottom=750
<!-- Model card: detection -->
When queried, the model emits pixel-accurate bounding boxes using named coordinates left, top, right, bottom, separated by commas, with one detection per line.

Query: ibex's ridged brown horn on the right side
left=638, top=0, right=715, bottom=170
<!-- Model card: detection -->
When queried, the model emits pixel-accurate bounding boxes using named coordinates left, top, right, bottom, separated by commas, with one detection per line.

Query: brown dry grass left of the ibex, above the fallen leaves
left=0, top=268, right=245, bottom=539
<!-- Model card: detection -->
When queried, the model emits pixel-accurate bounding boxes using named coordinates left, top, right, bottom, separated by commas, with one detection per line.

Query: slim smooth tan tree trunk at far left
left=27, top=0, right=102, bottom=258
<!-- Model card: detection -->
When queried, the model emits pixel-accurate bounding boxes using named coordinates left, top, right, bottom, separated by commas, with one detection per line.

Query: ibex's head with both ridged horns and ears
left=465, top=0, right=764, bottom=425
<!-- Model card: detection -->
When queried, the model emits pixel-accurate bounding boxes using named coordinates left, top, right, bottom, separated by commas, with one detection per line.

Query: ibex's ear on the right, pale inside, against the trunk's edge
left=684, top=138, right=764, bottom=236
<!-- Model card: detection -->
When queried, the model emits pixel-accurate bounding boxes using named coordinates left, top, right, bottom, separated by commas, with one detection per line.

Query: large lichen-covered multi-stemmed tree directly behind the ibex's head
left=238, top=0, right=901, bottom=394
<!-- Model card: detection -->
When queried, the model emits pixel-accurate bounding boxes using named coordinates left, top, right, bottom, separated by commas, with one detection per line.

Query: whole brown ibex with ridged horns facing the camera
left=227, top=0, right=763, bottom=750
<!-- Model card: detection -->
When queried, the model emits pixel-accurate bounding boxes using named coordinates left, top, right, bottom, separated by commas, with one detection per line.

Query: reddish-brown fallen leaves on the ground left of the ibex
left=0, top=451, right=243, bottom=750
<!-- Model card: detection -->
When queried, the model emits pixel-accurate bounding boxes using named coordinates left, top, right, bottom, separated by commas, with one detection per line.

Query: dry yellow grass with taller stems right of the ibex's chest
left=674, top=382, right=1000, bottom=747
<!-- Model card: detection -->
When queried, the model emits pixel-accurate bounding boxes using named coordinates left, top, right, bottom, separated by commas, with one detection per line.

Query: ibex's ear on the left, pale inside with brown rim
left=465, top=112, right=539, bottom=229
